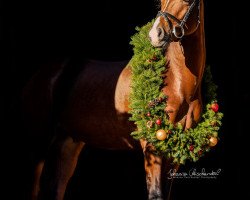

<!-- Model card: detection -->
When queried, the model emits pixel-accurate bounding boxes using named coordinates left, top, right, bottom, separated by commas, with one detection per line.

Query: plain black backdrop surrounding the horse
left=1, top=0, right=244, bottom=200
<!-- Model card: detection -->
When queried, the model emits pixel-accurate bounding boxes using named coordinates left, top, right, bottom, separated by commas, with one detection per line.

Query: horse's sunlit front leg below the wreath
left=140, top=140, right=163, bottom=200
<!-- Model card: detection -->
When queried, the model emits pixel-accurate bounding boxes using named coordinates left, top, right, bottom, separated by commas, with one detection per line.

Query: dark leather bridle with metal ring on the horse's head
left=157, top=0, right=200, bottom=40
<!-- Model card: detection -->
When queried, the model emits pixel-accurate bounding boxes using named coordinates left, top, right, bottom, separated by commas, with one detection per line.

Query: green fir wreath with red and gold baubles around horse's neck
left=130, top=22, right=223, bottom=164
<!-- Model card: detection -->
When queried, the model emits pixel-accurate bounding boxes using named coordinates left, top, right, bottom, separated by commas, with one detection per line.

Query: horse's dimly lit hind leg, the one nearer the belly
left=38, top=136, right=84, bottom=200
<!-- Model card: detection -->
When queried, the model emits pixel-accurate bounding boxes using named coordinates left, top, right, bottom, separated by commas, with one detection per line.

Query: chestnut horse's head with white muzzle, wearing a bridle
left=149, top=0, right=200, bottom=47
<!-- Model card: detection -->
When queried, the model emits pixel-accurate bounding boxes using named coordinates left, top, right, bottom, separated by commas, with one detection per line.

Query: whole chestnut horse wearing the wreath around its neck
left=23, top=0, right=206, bottom=200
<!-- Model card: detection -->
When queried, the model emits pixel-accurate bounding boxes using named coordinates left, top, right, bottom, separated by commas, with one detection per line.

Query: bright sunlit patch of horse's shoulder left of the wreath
left=115, top=64, right=131, bottom=113
